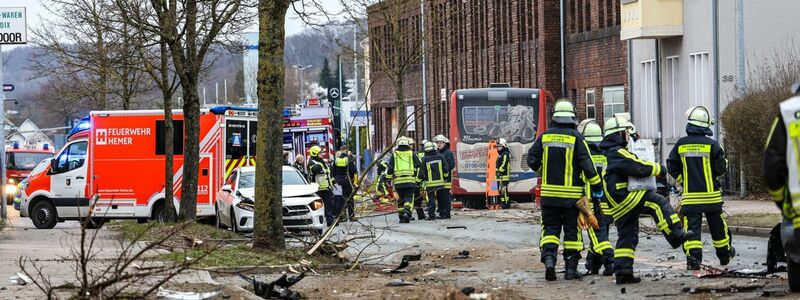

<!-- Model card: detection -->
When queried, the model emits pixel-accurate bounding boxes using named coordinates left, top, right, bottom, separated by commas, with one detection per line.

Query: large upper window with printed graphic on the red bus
left=456, top=89, right=538, bottom=144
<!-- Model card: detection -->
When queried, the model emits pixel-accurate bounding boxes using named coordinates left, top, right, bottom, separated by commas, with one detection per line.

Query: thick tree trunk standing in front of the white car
left=253, top=0, right=290, bottom=250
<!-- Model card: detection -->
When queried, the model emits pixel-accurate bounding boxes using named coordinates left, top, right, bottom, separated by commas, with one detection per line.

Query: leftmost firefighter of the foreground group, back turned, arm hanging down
left=527, top=101, right=603, bottom=281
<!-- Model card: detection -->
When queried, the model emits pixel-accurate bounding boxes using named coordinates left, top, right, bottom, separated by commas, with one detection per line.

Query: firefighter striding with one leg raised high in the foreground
left=600, top=117, right=694, bottom=284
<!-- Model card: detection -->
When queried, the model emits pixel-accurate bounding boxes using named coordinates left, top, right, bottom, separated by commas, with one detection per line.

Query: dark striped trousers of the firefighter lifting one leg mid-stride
left=614, top=191, right=683, bottom=276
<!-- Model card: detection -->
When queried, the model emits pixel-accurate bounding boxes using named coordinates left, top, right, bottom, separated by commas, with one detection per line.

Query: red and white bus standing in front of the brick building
left=450, top=84, right=553, bottom=201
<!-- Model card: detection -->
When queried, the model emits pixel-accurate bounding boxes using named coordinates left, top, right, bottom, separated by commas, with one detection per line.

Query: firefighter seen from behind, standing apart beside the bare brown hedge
left=667, top=106, right=735, bottom=270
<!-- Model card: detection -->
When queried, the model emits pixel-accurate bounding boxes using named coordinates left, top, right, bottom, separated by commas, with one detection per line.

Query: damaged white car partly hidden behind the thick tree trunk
left=215, top=166, right=326, bottom=233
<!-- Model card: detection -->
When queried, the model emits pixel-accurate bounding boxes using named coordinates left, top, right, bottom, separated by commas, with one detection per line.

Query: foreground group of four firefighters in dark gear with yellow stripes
left=527, top=101, right=735, bottom=284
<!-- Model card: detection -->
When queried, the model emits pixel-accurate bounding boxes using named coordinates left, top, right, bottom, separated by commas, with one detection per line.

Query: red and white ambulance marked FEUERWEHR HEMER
left=20, top=107, right=257, bottom=229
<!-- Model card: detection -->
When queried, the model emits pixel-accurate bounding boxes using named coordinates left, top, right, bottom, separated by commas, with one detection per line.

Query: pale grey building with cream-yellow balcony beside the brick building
left=621, top=0, right=800, bottom=162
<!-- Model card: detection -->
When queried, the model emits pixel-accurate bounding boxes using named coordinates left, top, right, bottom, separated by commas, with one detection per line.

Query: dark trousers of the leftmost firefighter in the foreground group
left=539, top=205, right=583, bottom=262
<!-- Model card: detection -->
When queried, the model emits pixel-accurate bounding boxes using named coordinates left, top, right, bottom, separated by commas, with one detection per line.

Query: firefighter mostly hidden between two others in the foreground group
left=578, top=119, right=614, bottom=276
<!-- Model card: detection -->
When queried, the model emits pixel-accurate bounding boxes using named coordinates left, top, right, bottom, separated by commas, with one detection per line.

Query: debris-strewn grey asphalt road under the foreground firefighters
left=315, top=210, right=787, bottom=299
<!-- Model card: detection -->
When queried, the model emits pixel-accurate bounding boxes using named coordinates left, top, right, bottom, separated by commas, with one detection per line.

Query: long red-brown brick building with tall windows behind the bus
left=368, top=0, right=627, bottom=149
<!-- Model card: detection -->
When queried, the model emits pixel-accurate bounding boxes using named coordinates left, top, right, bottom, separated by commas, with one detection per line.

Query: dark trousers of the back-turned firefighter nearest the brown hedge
left=681, top=203, right=732, bottom=263
